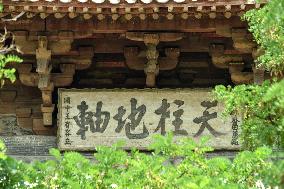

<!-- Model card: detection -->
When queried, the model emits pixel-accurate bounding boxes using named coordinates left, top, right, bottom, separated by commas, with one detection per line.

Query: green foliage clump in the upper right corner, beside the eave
left=244, top=0, right=284, bottom=74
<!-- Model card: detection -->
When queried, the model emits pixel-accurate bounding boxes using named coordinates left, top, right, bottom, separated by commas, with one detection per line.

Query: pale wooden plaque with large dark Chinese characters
left=57, top=89, right=239, bottom=150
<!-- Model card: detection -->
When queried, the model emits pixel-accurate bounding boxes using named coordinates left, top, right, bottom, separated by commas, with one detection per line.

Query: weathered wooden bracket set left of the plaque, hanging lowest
left=17, top=36, right=93, bottom=126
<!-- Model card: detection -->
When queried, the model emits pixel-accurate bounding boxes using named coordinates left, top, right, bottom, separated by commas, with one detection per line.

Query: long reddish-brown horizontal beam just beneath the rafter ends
left=0, top=16, right=247, bottom=35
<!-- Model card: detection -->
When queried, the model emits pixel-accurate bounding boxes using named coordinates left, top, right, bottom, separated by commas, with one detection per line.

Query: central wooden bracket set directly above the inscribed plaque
left=124, top=32, right=183, bottom=87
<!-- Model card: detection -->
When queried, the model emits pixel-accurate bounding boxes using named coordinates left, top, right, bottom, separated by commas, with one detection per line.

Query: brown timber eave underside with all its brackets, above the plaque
left=0, top=0, right=268, bottom=134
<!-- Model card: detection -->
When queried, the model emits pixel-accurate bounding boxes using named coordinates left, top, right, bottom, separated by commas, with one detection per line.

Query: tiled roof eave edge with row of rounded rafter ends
left=1, top=0, right=267, bottom=21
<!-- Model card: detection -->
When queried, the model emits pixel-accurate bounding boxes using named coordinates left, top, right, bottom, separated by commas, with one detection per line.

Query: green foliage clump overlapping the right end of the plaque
left=214, top=80, right=284, bottom=150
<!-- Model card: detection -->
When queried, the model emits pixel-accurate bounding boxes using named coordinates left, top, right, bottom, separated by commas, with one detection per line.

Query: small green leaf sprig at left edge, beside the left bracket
left=0, top=54, right=22, bottom=87
